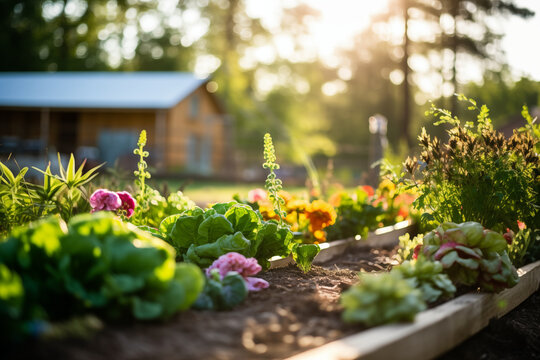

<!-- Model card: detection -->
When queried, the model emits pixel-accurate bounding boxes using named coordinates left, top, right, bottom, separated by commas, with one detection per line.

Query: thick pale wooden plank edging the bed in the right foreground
left=288, top=261, right=540, bottom=360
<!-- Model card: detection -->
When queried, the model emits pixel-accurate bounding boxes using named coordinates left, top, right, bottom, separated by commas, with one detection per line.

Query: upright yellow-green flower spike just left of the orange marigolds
left=263, top=133, right=287, bottom=225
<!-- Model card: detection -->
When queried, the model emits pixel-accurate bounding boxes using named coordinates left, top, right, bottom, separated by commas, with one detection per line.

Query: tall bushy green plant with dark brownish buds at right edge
left=405, top=95, right=540, bottom=260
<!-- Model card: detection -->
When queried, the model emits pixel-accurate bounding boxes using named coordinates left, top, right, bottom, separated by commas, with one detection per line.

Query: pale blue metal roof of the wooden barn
left=0, top=72, right=206, bottom=109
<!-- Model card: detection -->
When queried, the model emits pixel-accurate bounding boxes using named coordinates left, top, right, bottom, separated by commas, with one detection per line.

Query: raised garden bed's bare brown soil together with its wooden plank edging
left=12, top=224, right=540, bottom=360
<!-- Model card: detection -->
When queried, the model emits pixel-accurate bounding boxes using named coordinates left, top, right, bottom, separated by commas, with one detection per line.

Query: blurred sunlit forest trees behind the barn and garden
left=0, top=0, right=540, bottom=182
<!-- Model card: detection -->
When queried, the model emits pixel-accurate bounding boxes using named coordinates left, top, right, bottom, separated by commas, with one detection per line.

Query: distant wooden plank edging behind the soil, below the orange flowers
left=270, top=221, right=415, bottom=269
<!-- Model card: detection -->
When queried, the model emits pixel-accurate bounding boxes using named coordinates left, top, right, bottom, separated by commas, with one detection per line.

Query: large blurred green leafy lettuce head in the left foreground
left=0, top=212, right=204, bottom=336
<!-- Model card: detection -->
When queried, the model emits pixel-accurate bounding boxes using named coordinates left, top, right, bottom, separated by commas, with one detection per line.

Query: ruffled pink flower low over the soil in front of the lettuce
left=206, top=252, right=270, bottom=291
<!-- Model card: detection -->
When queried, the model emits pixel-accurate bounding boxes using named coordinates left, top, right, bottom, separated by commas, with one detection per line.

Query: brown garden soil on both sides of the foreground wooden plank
left=11, top=245, right=540, bottom=360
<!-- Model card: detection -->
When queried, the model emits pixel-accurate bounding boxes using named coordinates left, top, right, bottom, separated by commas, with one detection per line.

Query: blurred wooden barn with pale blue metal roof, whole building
left=0, top=72, right=231, bottom=176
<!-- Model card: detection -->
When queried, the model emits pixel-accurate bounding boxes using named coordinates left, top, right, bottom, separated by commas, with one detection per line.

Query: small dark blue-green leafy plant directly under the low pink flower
left=193, top=269, right=248, bottom=310
